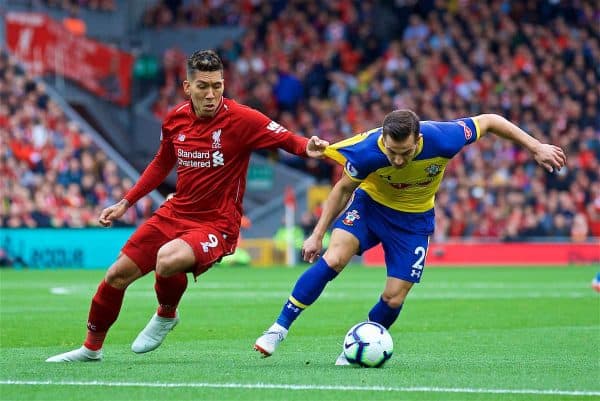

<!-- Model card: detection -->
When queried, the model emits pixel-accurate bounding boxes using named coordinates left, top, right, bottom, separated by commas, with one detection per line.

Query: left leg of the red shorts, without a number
left=121, top=216, right=173, bottom=274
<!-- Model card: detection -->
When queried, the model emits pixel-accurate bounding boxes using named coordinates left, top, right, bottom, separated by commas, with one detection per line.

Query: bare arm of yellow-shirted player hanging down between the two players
left=302, top=174, right=360, bottom=263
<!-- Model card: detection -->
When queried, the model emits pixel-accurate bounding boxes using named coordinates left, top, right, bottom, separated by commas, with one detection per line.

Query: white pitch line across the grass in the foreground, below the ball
left=0, top=380, right=600, bottom=396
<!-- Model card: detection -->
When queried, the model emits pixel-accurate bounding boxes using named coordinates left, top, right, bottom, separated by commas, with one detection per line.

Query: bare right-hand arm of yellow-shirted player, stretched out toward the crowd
left=474, top=114, right=567, bottom=172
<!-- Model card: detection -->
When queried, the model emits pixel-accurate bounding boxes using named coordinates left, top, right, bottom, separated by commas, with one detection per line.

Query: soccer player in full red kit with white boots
left=47, top=50, right=328, bottom=362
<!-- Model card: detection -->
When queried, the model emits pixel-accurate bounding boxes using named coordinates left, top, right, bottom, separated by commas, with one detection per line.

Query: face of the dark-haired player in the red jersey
left=183, top=71, right=225, bottom=117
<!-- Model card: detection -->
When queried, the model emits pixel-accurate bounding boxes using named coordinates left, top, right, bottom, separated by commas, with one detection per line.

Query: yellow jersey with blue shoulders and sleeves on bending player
left=325, top=118, right=481, bottom=213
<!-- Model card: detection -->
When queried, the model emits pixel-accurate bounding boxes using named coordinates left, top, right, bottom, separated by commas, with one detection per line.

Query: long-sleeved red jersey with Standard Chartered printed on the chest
left=125, top=98, right=308, bottom=239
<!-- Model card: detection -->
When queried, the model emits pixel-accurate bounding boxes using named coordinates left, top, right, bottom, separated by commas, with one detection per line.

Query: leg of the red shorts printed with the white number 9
left=179, top=226, right=233, bottom=276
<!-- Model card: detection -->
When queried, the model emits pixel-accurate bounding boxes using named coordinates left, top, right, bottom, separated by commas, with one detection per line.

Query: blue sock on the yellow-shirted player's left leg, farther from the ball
left=277, top=258, right=338, bottom=329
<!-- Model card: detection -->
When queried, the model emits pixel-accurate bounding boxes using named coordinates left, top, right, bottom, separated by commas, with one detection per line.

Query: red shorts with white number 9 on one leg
left=121, top=214, right=235, bottom=277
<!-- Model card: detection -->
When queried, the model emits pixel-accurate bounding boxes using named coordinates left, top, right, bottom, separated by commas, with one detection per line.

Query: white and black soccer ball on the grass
left=343, top=322, right=394, bottom=368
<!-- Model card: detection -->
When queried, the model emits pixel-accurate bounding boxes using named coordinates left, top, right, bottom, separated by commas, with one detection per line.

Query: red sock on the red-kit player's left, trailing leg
left=83, top=280, right=125, bottom=351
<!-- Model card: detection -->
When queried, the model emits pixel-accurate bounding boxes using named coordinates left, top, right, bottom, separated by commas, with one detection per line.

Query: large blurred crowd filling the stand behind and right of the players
left=146, top=0, right=600, bottom=241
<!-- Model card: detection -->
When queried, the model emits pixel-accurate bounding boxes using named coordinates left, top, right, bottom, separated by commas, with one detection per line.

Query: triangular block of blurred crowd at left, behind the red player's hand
left=0, top=53, right=152, bottom=228
